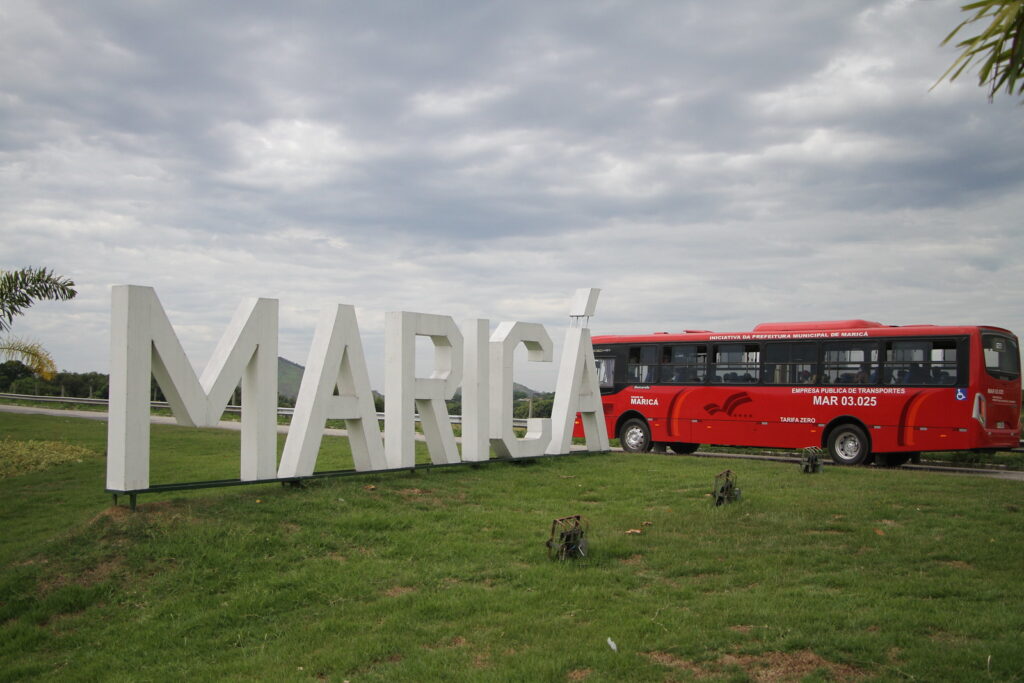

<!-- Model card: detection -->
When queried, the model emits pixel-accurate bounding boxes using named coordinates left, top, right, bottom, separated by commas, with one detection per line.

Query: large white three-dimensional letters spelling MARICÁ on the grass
left=106, top=285, right=608, bottom=492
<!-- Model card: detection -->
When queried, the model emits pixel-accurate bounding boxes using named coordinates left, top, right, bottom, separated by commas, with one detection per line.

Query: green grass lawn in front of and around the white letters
left=0, top=414, right=1024, bottom=681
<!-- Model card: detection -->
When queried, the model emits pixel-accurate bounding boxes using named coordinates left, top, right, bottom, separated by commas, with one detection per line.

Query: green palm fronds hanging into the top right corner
left=936, top=0, right=1024, bottom=100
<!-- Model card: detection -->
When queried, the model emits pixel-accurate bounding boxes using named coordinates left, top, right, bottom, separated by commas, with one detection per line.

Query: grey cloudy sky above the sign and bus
left=0, top=0, right=1024, bottom=388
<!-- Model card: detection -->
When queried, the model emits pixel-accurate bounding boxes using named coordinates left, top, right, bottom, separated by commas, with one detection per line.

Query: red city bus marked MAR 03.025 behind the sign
left=579, top=321, right=1021, bottom=465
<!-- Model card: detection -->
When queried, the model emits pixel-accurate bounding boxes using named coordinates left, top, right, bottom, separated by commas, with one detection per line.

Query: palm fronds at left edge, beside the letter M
left=0, top=267, right=78, bottom=380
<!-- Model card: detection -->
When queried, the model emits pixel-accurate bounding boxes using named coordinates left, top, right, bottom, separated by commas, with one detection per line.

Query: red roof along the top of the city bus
left=594, top=319, right=1014, bottom=344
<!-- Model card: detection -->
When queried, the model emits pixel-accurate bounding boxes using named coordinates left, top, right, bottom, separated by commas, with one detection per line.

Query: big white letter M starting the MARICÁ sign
left=106, top=285, right=278, bottom=490
